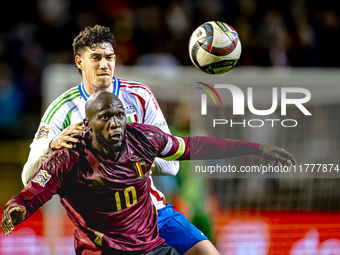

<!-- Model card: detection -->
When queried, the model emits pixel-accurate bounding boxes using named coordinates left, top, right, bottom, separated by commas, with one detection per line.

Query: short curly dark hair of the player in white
left=72, top=25, right=116, bottom=74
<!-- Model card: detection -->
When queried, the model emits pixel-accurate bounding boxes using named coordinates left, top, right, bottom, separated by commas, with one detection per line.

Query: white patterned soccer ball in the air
left=189, top=21, right=242, bottom=74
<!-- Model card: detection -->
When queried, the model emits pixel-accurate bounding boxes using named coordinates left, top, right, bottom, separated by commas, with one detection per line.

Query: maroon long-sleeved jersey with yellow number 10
left=6, top=123, right=259, bottom=252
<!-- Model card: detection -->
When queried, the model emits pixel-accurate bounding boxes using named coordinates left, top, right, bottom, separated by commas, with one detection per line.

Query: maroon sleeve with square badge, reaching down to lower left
left=5, top=149, right=71, bottom=224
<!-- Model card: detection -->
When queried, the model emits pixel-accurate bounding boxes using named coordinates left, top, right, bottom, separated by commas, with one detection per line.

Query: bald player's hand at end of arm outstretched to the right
left=260, top=144, right=296, bottom=166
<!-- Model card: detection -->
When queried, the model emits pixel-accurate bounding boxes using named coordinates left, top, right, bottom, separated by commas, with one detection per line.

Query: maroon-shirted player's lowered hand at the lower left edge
left=1, top=205, right=26, bottom=236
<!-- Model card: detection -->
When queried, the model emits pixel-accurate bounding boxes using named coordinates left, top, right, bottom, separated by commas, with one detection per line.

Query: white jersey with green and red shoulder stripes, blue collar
left=22, top=77, right=179, bottom=209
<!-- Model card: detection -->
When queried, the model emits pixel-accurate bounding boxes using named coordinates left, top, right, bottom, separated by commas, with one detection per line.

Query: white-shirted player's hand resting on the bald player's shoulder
left=50, top=121, right=85, bottom=150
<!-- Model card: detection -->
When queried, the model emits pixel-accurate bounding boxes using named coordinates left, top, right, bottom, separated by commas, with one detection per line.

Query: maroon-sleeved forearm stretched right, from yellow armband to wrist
left=178, top=136, right=261, bottom=160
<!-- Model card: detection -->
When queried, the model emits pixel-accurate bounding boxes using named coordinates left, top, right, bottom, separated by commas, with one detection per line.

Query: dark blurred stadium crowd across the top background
left=0, top=0, right=340, bottom=140
